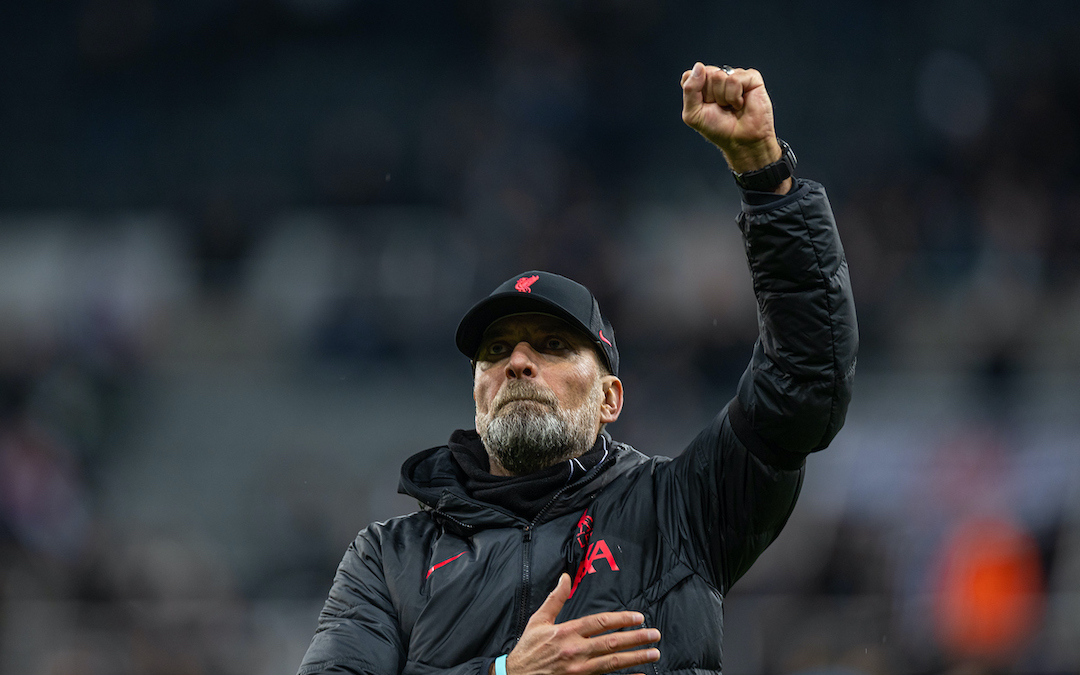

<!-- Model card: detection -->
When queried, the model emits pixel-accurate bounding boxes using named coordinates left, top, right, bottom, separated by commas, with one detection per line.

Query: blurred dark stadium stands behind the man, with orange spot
left=0, top=0, right=1080, bottom=675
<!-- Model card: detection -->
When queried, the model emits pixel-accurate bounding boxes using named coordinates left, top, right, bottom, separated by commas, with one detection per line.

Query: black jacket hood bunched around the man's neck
left=397, top=430, right=648, bottom=534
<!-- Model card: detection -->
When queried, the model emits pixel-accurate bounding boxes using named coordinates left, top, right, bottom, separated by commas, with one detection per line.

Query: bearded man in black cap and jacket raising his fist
left=299, top=63, right=858, bottom=675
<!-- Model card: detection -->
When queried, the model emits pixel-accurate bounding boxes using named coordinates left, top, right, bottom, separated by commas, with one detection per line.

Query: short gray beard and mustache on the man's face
left=476, top=380, right=600, bottom=475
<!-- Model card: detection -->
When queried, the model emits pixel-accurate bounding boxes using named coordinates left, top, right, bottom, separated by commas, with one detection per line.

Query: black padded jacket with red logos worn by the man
left=300, top=181, right=858, bottom=675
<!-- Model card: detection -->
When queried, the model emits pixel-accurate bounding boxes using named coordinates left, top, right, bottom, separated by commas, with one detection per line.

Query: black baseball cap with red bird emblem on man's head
left=456, top=270, right=619, bottom=375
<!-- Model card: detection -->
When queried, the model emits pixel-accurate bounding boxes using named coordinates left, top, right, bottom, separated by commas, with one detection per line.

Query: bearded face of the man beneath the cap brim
left=473, top=314, right=622, bottom=475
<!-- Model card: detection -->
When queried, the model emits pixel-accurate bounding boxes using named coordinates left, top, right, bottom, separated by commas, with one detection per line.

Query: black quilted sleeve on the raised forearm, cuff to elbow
left=739, top=181, right=859, bottom=453
